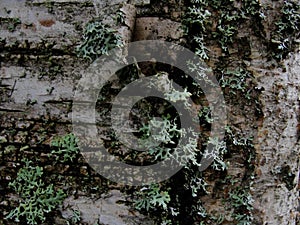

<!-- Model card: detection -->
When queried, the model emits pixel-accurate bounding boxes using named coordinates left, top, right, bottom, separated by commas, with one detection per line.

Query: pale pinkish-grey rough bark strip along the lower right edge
left=253, top=54, right=300, bottom=225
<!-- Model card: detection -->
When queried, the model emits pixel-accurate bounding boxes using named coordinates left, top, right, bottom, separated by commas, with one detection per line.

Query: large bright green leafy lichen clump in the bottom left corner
left=6, top=160, right=65, bottom=224
